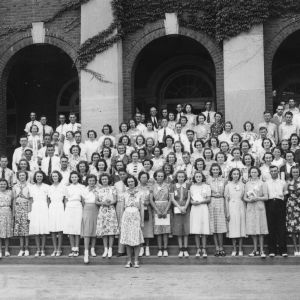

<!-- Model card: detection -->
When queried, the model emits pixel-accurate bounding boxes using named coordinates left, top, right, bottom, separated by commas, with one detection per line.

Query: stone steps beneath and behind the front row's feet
left=0, top=237, right=300, bottom=265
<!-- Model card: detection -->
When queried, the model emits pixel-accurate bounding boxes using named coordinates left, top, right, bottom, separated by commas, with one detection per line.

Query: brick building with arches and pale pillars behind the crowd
left=0, top=0, right=300, bottom=157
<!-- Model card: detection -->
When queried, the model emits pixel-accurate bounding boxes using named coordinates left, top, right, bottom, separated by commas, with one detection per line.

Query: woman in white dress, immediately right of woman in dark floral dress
left=29, top=171, right=49, bottom=256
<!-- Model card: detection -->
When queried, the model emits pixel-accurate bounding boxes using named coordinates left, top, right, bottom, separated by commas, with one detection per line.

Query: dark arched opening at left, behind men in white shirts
left=6, top=44, right=79, bottom=146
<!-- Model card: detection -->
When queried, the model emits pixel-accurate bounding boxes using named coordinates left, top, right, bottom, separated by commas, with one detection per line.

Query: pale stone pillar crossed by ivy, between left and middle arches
left=80, top=0, right=123, bottom=137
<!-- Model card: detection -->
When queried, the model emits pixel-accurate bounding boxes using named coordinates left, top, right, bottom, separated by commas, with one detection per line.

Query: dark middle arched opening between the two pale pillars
left=133, top=35, right=216, bottom=112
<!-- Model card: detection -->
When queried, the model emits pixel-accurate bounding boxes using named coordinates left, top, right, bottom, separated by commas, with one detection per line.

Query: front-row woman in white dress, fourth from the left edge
left=48, top=171, right=66, bottom=256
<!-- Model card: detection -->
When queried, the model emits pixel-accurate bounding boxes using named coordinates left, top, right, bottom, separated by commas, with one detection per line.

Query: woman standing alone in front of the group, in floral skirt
left=121, top=175, right=144, bottom=268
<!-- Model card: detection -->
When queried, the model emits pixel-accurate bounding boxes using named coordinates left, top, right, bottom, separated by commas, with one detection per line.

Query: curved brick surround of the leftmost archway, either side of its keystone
left=0, top=30, right=79, bottom=153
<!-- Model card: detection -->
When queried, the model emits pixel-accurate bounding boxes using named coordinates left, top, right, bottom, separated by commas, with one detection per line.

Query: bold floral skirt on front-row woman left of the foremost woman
left=96, top=205, right=119, bottom=237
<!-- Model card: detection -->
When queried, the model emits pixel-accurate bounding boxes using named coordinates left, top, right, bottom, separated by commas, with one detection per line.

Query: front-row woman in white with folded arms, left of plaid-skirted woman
left=190, top=171, right=211, bottom=257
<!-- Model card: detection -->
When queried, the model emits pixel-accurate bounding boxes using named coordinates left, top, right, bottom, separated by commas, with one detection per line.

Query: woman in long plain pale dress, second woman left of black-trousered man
left=224, top=168, right=246, bottom=256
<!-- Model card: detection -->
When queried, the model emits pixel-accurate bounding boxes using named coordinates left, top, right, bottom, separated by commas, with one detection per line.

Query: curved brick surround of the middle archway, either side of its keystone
left=123, top=20, right=225, bottom=118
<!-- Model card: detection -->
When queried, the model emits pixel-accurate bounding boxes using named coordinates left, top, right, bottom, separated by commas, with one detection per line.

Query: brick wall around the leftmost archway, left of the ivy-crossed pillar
left=0, top=0, right=80, bottom=153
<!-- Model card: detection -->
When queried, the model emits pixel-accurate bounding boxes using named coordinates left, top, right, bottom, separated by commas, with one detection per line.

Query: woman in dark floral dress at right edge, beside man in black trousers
left=286, top=166, right=300, bottom=256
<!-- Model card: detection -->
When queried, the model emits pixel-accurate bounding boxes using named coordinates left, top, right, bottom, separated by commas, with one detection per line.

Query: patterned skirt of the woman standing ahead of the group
left=120, top=207, right=144, bottom=247
